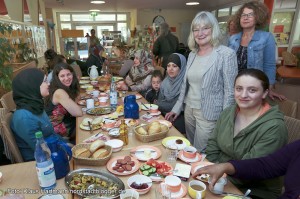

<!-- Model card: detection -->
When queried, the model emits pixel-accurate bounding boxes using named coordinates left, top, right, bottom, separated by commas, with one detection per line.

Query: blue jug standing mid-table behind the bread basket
left=124, top=95, right=139, bottom=119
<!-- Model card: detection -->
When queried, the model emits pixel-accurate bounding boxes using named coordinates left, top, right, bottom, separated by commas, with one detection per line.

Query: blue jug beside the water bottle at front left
left=45, top=135, right=72, bottom=179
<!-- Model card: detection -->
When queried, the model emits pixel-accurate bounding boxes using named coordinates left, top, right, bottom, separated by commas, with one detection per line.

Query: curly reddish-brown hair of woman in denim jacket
left=234, top=1, right=269, bottom=32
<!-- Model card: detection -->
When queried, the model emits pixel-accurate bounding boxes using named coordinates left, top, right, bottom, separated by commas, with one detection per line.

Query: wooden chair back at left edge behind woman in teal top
left=1, top=113, right=24, bottom=163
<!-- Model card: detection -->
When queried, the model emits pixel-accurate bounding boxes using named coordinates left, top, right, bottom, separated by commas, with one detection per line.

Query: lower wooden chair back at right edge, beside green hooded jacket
left=284, top=116, right=300, bottom=143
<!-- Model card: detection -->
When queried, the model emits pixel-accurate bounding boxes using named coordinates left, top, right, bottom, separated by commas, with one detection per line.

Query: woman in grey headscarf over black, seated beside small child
left=157, top=53, right=186, bottom=133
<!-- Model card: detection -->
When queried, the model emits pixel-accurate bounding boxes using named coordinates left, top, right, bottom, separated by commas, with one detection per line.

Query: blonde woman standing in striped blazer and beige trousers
left=165, top=11, right=237, bottom=152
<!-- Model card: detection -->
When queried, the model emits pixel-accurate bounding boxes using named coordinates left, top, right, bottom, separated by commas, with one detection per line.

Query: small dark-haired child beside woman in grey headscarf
left=144, top=70, right=163, bottom=104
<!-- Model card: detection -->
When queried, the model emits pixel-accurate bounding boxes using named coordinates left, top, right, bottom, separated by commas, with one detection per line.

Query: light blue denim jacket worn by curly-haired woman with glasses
left=229, top=30, right=276, bottom=85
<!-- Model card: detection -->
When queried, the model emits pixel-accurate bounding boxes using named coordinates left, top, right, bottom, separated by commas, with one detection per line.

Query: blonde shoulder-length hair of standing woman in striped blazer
left=188, top=11, right=222, bottom=52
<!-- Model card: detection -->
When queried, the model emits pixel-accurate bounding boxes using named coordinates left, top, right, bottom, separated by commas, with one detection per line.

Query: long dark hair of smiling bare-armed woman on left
left=46, top=62, right=79, bottom=104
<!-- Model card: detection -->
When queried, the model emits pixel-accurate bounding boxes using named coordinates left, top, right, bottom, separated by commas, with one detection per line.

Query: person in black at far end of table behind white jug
left=81, top=45, right=105, bottom=76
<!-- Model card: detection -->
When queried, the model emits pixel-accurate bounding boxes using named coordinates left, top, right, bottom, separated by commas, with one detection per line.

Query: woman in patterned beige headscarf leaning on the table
left=118, top=50, right=154, bottom=92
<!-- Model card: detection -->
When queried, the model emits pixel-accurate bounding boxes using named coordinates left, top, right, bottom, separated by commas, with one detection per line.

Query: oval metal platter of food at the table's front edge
left=65, top=169, right=125, bottom=198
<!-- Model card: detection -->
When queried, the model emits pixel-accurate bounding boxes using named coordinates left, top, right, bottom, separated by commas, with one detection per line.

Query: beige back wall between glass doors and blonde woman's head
left=137, top=9, right=199, bottom=44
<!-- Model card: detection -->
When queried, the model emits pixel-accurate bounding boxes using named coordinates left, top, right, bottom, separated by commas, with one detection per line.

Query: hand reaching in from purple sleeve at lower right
left=192, top=163, right=235, bottom=190
